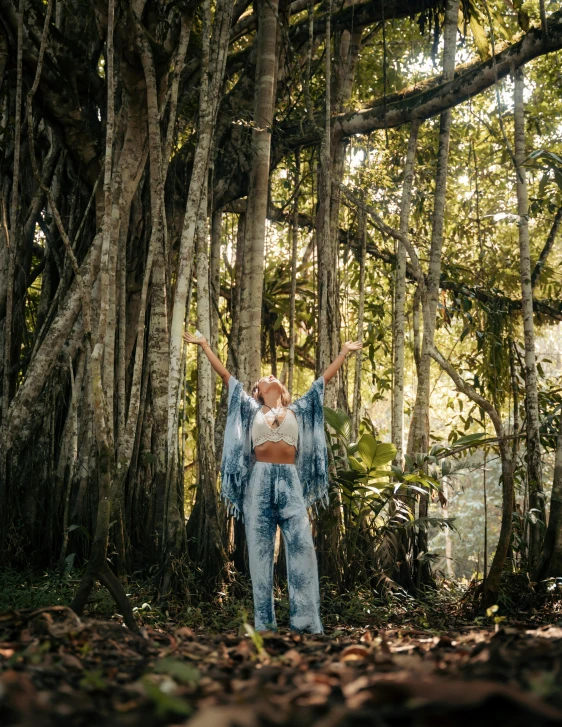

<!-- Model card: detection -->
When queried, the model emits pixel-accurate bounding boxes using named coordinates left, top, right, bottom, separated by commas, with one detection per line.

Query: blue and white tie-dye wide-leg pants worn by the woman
left=243, top=462, right=323, bottom=634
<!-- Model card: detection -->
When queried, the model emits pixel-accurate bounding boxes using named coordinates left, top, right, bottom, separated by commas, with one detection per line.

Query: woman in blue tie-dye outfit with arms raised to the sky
left=184, top=333, right=362, bottom=634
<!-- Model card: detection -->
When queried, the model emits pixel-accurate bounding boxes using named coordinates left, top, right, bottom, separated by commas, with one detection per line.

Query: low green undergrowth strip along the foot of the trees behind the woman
left=0, top=568, right=562, bottom=633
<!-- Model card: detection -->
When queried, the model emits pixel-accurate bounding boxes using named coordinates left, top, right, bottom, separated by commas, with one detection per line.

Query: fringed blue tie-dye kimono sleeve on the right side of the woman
left=289, top=376, right=329, bottom=511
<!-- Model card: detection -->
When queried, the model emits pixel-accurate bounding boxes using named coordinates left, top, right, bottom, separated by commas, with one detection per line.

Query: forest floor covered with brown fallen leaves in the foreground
left=0, top=578, right=562, bottom=727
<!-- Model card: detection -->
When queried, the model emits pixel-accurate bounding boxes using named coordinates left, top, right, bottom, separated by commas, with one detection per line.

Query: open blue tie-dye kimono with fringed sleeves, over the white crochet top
left=221, top=376, right=328, bottom=517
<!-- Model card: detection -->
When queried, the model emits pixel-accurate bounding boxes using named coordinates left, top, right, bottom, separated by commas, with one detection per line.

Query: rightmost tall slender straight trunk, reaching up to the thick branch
left=513, top=68, right=545, bottom=568
